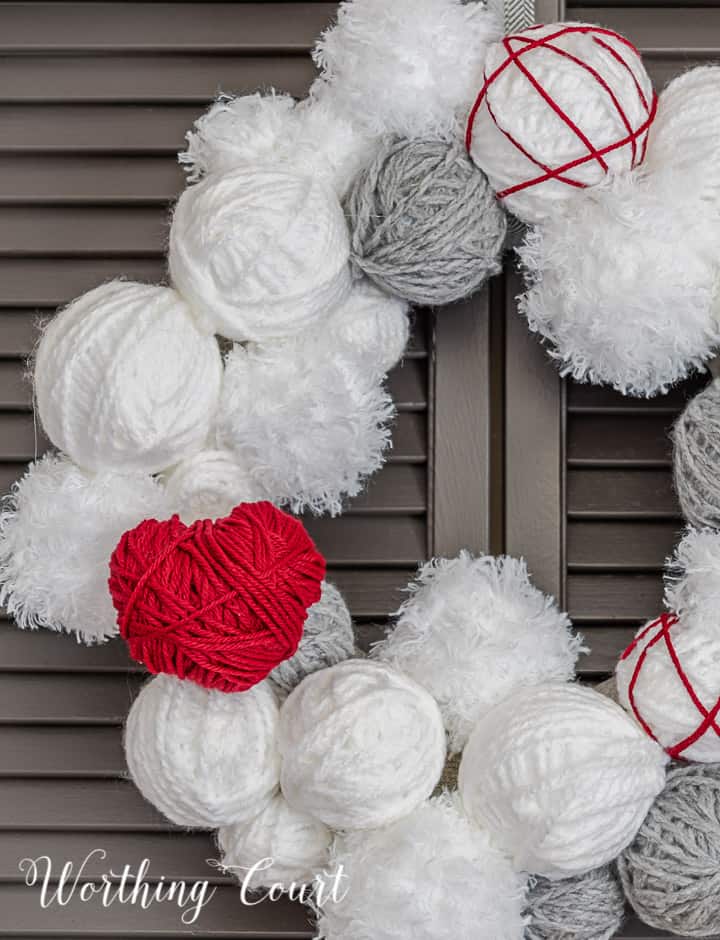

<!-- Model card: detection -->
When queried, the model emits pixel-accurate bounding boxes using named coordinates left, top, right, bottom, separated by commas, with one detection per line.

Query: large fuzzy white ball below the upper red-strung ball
left=519, top=174, right=720, bottom=396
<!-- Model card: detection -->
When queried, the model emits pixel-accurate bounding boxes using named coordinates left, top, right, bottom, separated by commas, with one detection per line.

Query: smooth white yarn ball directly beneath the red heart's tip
left=125, top=675, right=280, bottom=829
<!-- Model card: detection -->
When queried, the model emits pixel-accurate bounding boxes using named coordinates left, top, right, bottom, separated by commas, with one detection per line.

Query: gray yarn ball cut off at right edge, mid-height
left=672, top=379, right=720, bottom=529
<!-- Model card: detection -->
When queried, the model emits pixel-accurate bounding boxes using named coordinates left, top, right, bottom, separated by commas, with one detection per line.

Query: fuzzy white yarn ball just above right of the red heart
left=218, top=336, right=393, bottom=514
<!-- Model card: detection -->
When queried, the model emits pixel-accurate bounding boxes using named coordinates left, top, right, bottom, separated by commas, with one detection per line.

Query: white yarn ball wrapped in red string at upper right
left=466, top=23, right=657, bottom=224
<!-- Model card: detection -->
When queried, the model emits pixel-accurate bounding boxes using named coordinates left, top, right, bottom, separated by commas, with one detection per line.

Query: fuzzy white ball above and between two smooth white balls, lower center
left=373, top=552, right=583, bottom=751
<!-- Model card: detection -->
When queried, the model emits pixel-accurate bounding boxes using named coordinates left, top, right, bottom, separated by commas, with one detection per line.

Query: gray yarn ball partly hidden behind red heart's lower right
left=268, top=581, right=355, bottom=696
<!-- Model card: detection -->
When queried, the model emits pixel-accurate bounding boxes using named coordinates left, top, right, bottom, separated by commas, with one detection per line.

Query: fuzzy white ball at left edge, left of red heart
left=0, top=455, right=169, bottom=643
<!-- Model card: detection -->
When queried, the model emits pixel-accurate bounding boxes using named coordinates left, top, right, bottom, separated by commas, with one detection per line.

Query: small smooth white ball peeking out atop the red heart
left=165, top=450, right=264, bottom=525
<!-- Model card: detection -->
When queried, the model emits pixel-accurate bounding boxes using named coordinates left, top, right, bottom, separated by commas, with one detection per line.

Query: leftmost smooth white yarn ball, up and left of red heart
left=35, top=281, right=222, bottom=473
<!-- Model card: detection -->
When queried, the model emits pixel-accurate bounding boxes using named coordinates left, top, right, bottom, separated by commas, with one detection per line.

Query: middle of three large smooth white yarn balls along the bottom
left=280, top=659, right=445, bottom=830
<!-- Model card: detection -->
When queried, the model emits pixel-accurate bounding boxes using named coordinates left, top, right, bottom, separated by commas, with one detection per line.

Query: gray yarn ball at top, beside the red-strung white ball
left=346, top=140, right=506, bottom=305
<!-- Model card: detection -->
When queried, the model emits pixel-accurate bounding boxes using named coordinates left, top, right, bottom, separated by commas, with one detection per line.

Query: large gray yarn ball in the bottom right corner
left=617, top=764, right=720, bottom=937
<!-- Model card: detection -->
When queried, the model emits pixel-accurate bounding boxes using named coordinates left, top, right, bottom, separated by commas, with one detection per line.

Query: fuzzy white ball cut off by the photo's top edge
left=315, top=0, right=503, bottom=140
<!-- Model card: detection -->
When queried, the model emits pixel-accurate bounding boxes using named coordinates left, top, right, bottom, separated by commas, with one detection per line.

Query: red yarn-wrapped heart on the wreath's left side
left=109, top=502, right=325, bottom=692
